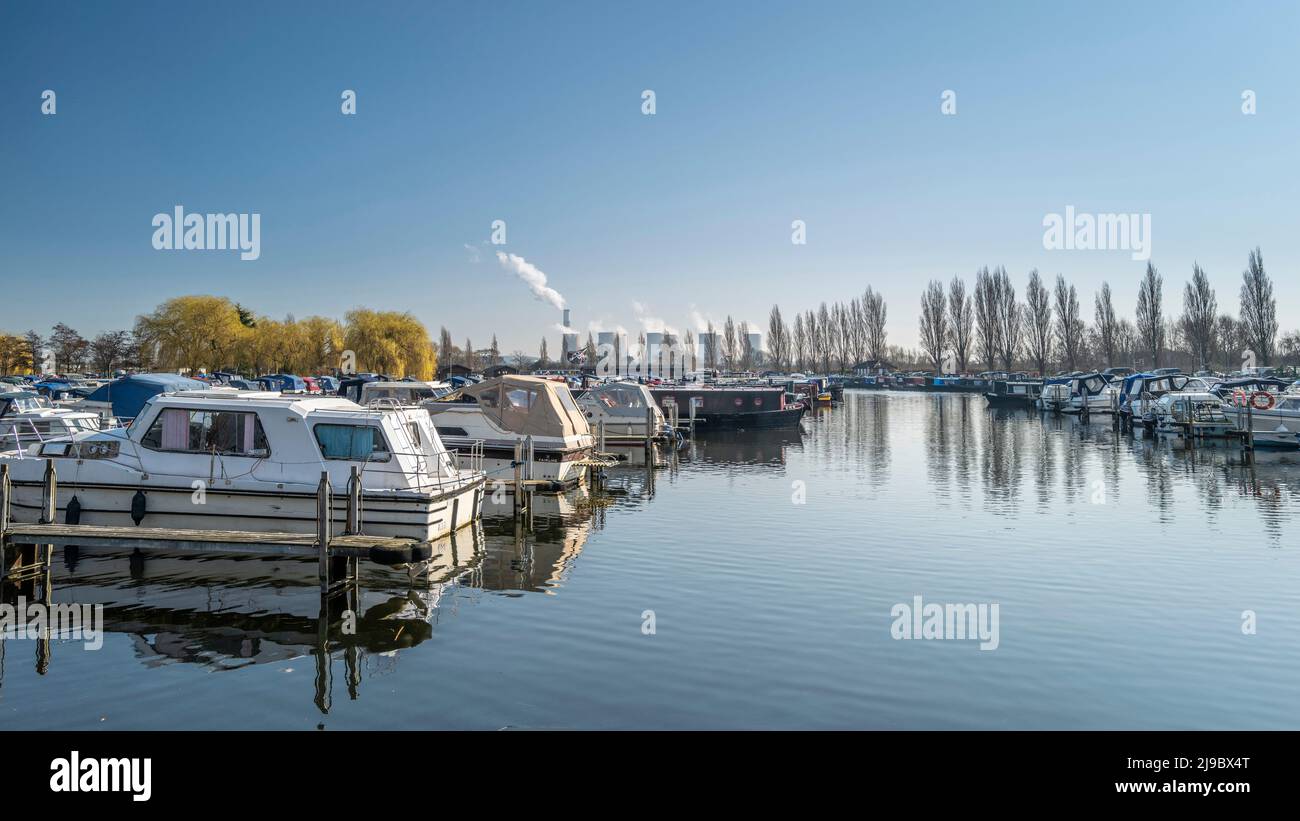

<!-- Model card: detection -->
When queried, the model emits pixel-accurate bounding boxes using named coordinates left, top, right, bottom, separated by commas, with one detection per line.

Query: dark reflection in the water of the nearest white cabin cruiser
left=22, top=524, right=484, bottom=712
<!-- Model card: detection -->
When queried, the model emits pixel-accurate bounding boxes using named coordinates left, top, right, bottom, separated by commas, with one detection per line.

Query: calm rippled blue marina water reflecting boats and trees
left=0, top=391, right=1300, bottom=729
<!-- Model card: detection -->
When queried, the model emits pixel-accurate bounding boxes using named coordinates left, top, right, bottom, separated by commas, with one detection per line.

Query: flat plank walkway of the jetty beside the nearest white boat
left=3, top=524, right=417, bottom=557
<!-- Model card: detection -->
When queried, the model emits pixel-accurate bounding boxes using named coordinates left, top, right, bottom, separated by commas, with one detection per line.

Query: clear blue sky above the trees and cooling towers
left=0, top=1, right=1300, bottom=353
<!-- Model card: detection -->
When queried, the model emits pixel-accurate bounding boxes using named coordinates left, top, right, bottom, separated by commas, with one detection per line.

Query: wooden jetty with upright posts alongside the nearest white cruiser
left=0, top=460, right=433, bottom=594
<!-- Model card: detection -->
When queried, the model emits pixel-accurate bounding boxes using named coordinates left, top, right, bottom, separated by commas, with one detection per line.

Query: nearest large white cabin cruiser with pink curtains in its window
left=0, top=391, right=484, bottom=540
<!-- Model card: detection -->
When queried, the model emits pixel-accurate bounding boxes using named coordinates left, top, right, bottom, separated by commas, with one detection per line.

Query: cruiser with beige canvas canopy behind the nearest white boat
left=421, top=374, right=595, bottom=487
